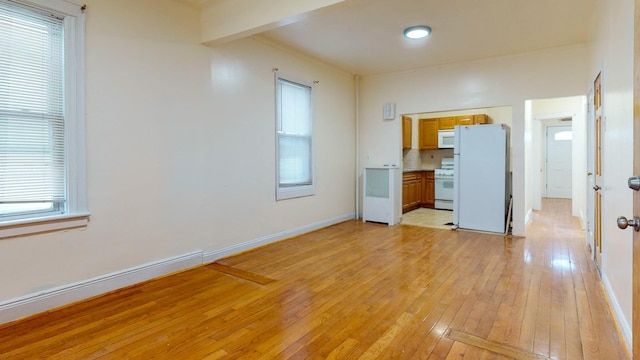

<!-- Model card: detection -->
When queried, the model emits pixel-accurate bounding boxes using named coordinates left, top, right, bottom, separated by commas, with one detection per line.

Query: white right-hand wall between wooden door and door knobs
left=588, top=0, right=637, bottom=345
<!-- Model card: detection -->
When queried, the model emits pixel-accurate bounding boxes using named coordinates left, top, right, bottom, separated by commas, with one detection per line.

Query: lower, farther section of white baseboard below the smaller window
left=202, top=213, right=356, bottom=264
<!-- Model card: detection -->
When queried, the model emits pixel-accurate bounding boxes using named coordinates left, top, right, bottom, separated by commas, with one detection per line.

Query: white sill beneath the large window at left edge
left=0, top=213, right=89, bottom=239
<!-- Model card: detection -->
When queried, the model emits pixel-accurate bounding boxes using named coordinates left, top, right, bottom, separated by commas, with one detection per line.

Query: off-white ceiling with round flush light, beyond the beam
left=258, top=0, right=596, bottom=75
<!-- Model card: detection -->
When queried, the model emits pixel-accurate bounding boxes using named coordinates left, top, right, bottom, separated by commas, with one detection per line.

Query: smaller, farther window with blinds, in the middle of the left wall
left=276, top=75, right=315, bottom=200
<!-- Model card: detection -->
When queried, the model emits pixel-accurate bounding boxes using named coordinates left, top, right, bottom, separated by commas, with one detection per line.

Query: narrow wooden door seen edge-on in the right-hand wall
left=593, top=73, right=602, bottom=271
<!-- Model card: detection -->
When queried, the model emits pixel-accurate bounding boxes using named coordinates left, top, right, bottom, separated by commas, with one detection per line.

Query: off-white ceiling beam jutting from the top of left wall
left=200, top=0, right=345, bottom=45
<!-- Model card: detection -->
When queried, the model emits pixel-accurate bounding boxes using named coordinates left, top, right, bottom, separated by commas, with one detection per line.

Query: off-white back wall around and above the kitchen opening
left=359, top=46, right=588, bottom=235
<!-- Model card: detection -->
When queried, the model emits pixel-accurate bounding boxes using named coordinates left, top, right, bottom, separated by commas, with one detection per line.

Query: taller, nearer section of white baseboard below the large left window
left=0, top=251, right=202, bottom=324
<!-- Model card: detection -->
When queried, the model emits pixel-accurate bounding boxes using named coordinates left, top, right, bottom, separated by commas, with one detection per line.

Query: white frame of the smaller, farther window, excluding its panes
left=274, top=71, right=316, bottom=201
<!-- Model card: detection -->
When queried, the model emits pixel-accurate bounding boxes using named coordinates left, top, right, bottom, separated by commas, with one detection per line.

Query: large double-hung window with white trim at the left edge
left=0, top=0, right=86, bottom=237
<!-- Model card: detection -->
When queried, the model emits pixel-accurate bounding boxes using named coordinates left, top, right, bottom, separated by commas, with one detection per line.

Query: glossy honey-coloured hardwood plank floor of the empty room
left=0, top=200, right=628, bottom=360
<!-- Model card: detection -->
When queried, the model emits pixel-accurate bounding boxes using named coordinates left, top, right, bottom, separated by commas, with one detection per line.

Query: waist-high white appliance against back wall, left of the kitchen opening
left=362, top=166, right=402, bottom=225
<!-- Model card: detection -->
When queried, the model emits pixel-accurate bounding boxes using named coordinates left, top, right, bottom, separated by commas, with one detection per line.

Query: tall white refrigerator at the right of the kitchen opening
left=453, top=124, right=509, bottom=233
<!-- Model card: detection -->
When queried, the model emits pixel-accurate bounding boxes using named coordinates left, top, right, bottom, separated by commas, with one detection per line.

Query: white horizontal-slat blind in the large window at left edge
left=0, top=2, right=66, bottom=219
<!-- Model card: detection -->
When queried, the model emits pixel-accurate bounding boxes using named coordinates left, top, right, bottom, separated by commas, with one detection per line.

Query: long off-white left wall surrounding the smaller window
left=0, top=0, right=355, bottom=304
